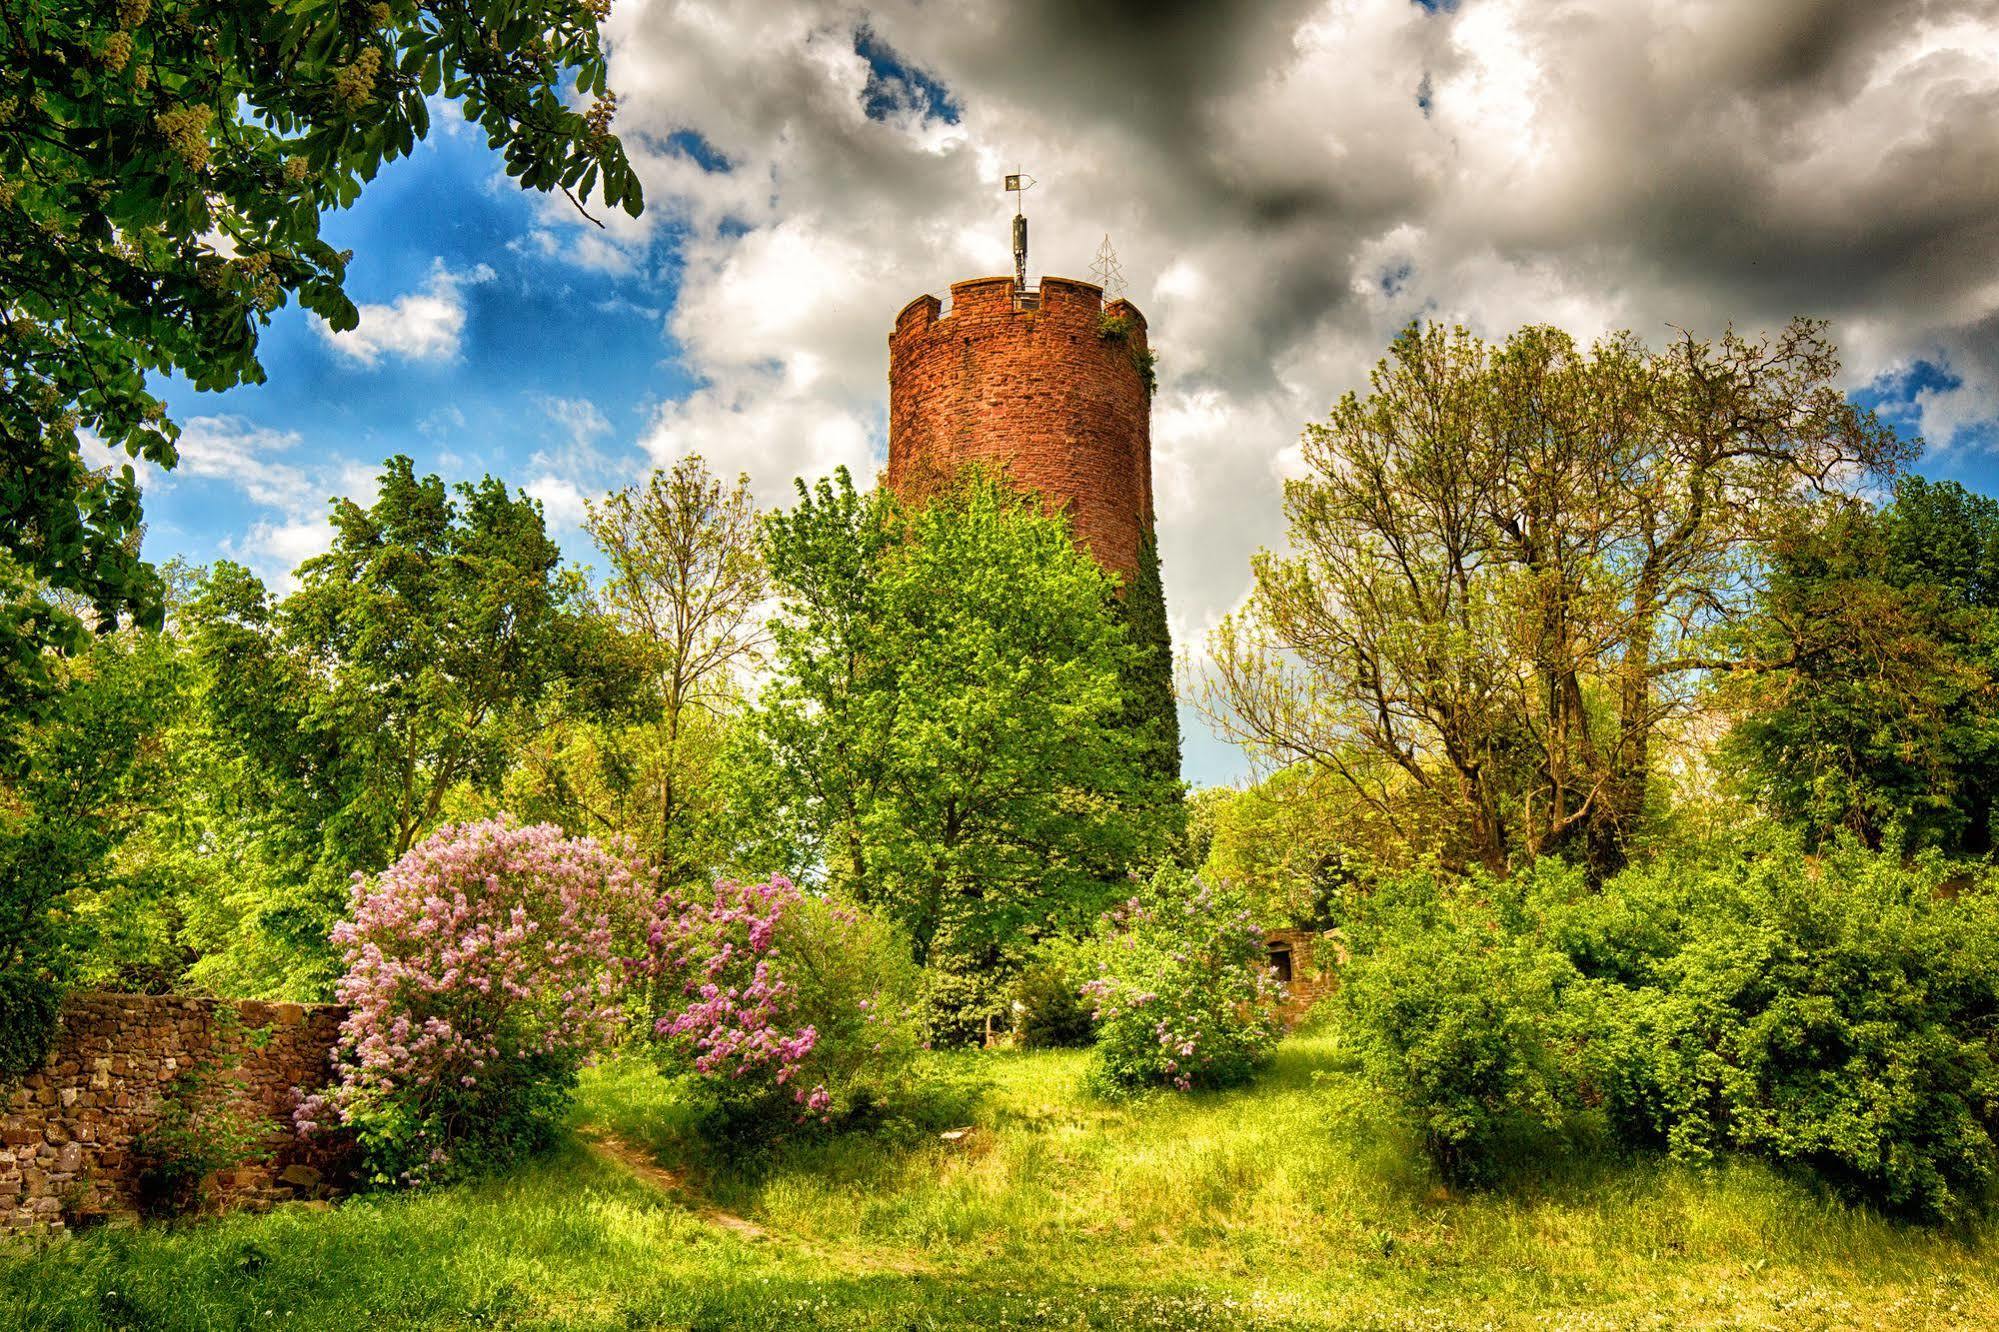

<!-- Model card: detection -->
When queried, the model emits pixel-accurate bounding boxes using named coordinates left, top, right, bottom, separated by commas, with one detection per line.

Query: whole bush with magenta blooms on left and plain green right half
left=652, top=878, right=943, bottom=1146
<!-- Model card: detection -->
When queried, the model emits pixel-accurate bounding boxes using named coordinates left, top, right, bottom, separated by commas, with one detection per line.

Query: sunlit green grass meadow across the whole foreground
left=0, top=1038, right=1999, bottom=1332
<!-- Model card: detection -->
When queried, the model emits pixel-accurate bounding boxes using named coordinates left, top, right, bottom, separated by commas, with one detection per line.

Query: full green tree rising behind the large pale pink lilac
left=190, top=458, right=607, bottom=992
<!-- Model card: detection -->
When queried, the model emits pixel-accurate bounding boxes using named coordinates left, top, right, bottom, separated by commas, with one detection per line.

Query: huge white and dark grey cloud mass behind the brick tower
left=534, top=0, right=1999, bottom=664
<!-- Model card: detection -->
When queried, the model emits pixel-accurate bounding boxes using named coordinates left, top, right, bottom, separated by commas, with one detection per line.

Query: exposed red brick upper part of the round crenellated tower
left=888, top=278, right=1153, bottom=584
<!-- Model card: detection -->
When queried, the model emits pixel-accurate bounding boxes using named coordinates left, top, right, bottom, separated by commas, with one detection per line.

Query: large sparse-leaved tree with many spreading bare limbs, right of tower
left=1205, top=320, right=1913, bottom=872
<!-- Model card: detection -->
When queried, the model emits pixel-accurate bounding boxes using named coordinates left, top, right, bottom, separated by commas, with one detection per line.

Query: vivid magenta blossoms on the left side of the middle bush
left=650, top=876, right=832, bottom=1116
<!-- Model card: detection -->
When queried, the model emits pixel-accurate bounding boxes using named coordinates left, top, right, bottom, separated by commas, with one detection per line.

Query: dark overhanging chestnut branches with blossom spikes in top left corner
left=0, top=0, right=642, bottom=658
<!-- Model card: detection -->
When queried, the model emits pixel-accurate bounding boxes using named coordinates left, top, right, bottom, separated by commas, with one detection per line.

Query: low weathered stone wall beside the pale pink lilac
left=0, top=992, right=346, bottom=1234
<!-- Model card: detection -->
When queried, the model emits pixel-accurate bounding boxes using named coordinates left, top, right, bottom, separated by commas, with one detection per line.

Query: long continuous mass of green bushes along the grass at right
left=1339, top=842, right=1999, bottom=1218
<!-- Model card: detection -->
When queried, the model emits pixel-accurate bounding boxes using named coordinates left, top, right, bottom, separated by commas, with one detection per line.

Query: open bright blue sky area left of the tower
left=146, top=132, right=690, bottom=576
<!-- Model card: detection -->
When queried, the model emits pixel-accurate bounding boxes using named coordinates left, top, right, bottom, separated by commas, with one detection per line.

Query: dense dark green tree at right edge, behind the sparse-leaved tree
left=1727, top=476, right=1999, bottom=854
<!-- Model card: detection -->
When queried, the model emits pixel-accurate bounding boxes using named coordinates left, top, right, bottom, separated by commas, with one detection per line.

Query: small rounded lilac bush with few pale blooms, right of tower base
left=1077, top=868, right=1281, bottom=1092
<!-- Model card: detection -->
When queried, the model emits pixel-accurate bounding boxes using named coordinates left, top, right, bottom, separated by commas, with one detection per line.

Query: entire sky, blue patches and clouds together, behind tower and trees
left=128, top=0, right=1999, bottom=782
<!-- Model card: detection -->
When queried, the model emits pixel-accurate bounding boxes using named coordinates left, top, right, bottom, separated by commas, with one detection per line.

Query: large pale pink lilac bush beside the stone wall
left=294, top=818, right=654, bottom=1184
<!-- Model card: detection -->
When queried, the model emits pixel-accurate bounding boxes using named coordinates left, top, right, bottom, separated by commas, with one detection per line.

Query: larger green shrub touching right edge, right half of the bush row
left=1551, top=842, right=1999, bottom=1218
